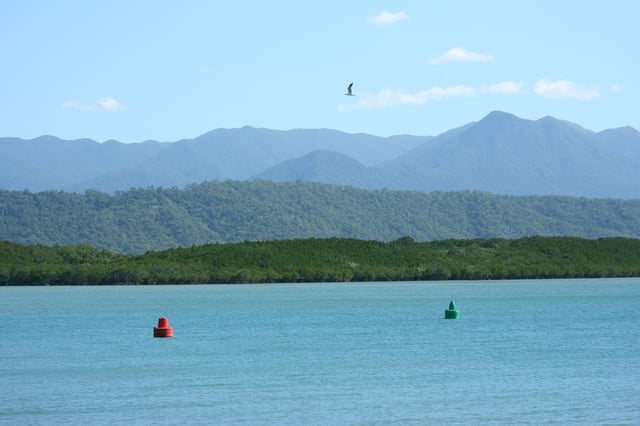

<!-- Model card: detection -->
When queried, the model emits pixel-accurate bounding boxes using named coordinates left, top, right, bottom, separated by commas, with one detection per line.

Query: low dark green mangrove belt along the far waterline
left=0, top=237, right=640, bottom=285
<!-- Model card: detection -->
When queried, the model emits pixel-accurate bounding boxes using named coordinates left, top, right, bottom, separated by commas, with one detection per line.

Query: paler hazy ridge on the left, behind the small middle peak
left=0, top=126, right=430, bottom=192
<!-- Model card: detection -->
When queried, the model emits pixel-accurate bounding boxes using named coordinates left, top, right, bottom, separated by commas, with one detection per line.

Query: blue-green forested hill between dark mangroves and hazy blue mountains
left=0, top=180, right=640, bottom=253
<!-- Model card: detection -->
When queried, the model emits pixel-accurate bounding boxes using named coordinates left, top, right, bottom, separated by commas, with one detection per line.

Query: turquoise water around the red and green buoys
left=0, top=279, right=640, bottom=425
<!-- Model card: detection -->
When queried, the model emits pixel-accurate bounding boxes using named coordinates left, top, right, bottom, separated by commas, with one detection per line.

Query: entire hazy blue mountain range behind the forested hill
left=0, top=111, right=640, bottom=199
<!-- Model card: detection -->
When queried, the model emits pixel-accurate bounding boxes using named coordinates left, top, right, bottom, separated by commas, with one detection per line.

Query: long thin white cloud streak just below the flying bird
left=338, top=85, right=477, bottom=111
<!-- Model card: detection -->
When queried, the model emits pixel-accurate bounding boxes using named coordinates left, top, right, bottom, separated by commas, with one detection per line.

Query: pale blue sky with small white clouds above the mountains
left=0, top=0, right=640, bottom=143
